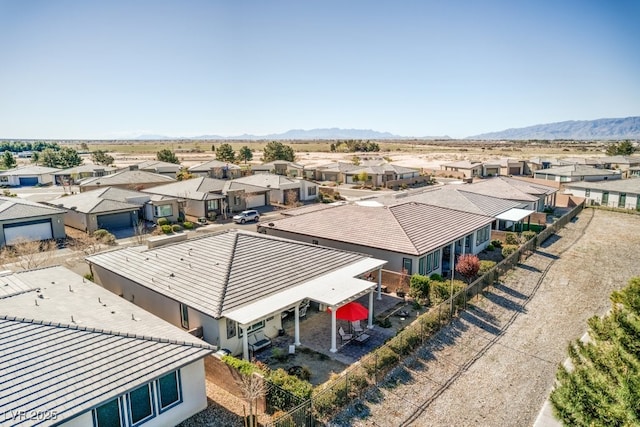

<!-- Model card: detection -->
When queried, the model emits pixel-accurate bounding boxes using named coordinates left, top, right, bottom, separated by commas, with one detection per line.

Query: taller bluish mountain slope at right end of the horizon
left=467, top=117, right=640, bottom=140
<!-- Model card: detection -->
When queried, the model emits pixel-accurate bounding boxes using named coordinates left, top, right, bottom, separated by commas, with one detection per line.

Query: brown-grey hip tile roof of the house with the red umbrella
left=86, top=230, right=369, bottom=318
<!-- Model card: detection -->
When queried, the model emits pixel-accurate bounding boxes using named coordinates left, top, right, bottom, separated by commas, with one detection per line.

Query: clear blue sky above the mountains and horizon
left=0, top=0, right=640, bottom=139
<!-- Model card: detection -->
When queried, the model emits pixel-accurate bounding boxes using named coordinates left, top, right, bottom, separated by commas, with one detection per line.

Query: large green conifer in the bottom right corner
left=550, top=277, right=640, bottom=426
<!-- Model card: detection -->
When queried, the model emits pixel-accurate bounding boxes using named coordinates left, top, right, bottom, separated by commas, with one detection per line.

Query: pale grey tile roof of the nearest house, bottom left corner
left=0, top=266, right=212, bottom=425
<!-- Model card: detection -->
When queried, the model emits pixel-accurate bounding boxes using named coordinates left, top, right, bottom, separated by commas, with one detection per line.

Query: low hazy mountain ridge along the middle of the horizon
left=134, top=128, right=450, bottom=140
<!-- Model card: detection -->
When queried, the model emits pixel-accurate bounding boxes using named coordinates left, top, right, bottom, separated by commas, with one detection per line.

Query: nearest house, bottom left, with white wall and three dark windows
left=0, top=266, right=214, bottom=427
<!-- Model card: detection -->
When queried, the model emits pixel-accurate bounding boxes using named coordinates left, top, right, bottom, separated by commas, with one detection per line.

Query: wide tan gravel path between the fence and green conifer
left=334, top=209, right=640, bottom=427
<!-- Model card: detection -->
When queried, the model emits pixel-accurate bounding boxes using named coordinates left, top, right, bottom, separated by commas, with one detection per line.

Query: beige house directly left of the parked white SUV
left=143, top=177, right=270, bottom=219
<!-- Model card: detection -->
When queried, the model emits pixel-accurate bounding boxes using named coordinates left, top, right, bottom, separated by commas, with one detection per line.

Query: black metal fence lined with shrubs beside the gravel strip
left=267, top=203, right=584, bottom=427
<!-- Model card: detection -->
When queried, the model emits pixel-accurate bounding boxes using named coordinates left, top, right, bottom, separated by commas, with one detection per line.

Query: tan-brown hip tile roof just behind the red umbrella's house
left=260, top=202, right=493, bottom=255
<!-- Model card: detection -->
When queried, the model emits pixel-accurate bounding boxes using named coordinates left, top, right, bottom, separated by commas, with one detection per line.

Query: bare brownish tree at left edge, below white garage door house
left=0, top=239, right=58, bottom=270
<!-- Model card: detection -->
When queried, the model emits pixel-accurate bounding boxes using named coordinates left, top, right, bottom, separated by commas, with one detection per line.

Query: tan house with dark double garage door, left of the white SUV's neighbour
left=48, top=187, right=180, bottom=233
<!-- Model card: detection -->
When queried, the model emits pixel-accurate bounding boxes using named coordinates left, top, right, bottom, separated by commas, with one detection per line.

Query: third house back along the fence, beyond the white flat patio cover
left=461, top=176, right=558, bottom=212
